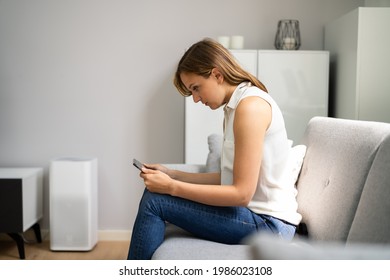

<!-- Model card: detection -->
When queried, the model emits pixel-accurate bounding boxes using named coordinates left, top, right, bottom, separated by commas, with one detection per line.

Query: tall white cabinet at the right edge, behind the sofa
left=325, top=8, right=390, bottom=122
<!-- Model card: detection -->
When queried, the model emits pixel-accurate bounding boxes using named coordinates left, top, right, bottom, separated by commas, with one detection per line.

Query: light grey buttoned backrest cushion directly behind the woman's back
left=297, top=117, right=390, bottom=242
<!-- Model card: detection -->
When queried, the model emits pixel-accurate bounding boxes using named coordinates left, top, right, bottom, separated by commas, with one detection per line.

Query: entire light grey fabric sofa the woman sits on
left=153, top=117, right=390, bottom=260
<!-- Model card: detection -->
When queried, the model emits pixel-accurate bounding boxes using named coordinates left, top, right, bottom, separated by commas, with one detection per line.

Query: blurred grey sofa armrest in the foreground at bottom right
left=245, top=233, right=390, bottom=260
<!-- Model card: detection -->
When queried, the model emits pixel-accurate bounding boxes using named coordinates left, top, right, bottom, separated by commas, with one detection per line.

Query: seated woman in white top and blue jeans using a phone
left=128, top=39, right=301, bottom=259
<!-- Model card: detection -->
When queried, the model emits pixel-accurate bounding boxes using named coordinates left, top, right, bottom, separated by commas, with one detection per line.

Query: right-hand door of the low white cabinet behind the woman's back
left=258, top=51, right=329, bottom=144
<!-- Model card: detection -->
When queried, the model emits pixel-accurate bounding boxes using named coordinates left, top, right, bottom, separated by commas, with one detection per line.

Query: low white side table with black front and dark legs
left=0, top=168, right=43, bottom=259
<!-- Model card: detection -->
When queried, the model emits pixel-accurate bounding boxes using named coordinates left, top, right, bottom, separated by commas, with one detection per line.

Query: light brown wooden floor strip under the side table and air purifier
left=0, top=231, right=129, bottom=260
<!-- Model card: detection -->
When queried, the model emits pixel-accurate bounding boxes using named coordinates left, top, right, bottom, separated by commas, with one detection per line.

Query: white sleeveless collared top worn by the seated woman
left=221, top=82, right=302, bottom=225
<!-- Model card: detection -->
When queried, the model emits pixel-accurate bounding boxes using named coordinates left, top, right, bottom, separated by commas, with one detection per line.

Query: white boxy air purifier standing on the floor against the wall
left=50, top=158, right=98, bottom=251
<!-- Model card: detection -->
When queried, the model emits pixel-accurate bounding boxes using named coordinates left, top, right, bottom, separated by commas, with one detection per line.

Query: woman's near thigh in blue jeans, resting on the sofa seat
left=143, top=192, right=272, bottom=244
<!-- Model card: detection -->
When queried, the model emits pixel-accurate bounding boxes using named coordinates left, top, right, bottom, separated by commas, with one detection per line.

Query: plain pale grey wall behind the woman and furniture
left=0, top=0, right=364, bottom=234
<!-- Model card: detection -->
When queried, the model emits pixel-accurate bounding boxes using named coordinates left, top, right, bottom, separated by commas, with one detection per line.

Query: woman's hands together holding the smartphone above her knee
left=140, top=164, right=173, bottom=194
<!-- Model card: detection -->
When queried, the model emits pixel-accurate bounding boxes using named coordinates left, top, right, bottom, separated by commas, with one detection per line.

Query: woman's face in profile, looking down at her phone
left=180, top=69, right=226, bottom=110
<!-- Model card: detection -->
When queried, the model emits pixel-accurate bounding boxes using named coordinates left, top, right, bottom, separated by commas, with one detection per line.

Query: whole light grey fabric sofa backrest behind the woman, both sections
left=297, top=117, right=390, bottom=243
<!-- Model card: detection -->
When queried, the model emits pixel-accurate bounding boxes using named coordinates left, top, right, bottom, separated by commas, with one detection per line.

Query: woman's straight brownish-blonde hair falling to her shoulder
left=173, top=38, right=267, bottom=96
